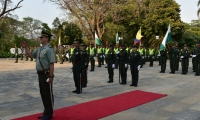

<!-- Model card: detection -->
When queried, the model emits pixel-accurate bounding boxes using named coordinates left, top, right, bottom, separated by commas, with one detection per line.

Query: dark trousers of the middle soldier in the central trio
left=119, top=62, right=128, bottom=84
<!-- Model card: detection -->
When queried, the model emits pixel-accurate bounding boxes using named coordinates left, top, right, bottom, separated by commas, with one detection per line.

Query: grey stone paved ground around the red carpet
left=0, top=59, right=200, bottom=120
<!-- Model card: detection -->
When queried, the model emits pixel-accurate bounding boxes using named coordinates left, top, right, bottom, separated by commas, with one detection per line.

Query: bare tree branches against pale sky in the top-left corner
left=0, top=0, right=23, bottom=19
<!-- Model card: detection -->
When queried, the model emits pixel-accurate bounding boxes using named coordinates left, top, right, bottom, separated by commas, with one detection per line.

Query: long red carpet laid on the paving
left=15, top=90, right=167, bottom=120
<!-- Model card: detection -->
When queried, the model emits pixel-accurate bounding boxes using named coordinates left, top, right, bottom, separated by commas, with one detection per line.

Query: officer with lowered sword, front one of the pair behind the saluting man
left=72, top=40, right=83, bottom=94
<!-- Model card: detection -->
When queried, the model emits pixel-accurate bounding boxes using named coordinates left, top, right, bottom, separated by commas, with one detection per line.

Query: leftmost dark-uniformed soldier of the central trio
left=107, top=45, right=116, bottom=83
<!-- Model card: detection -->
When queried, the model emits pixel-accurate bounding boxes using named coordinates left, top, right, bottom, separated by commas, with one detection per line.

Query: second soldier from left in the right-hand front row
left=169, top=44, right=179, bottom=74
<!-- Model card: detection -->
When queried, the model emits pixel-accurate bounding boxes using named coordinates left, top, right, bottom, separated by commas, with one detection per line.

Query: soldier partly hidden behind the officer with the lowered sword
left=81, top=43, right=89, bottom=88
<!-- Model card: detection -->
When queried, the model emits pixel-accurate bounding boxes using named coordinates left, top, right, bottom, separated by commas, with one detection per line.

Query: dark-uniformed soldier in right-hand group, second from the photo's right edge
left=180, top=45, right=190, bottom=75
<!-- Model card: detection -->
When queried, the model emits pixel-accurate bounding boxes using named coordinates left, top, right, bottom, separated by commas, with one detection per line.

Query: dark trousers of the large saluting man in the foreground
left=38, top=74, right=54, bottom=117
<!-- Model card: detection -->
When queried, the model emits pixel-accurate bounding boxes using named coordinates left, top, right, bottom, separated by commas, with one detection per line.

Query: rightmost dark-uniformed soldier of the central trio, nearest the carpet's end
left=129, top=45, right=141, bottom=87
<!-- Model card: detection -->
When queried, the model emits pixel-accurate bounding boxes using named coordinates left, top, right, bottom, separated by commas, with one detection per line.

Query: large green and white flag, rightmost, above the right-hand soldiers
left=159, top=25, right=172, bottom=50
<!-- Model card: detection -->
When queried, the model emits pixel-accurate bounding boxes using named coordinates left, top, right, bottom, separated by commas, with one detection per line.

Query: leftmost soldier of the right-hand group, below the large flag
left=159, top=49, right=167, bottom=73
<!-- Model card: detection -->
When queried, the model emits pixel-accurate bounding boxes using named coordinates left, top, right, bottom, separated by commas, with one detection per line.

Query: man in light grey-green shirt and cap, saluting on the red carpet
left=22, top=29, right=54, bottom=120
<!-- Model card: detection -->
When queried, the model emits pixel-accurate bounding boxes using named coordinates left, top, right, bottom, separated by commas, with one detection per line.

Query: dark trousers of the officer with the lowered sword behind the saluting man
left=73, top=62, right=82, bottom=92
